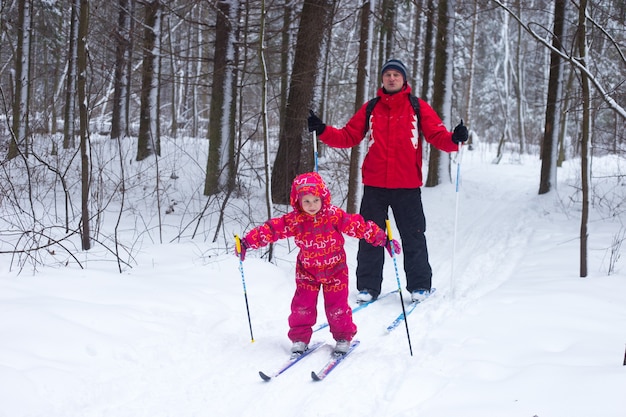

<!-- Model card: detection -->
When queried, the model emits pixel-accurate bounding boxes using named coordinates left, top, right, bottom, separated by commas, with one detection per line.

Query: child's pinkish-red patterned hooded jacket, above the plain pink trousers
left=244, top=172, right=386, bottom=283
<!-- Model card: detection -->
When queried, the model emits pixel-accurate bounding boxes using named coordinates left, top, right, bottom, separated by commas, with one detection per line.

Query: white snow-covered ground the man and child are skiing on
left=0, top=144, right=626, bottom=417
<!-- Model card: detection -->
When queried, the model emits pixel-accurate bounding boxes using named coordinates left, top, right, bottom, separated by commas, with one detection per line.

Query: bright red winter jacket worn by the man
left=319, top=85, right=458, bottom=188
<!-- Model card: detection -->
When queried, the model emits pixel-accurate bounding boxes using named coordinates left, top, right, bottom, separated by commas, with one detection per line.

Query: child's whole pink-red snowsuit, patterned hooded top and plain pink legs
left=244, top=172, right=387, bottom=344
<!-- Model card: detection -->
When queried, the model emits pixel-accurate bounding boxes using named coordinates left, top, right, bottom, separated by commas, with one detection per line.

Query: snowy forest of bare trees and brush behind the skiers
left=0, top=0, right=626, bottom=276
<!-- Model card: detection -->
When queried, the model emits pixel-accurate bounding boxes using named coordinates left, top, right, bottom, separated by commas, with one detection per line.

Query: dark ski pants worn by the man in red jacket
left=356, top=186, right=432, bottom=297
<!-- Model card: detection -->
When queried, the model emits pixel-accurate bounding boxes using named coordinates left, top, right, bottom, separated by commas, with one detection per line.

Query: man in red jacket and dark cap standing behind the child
left=308, top=59, right=468, bottom=302
